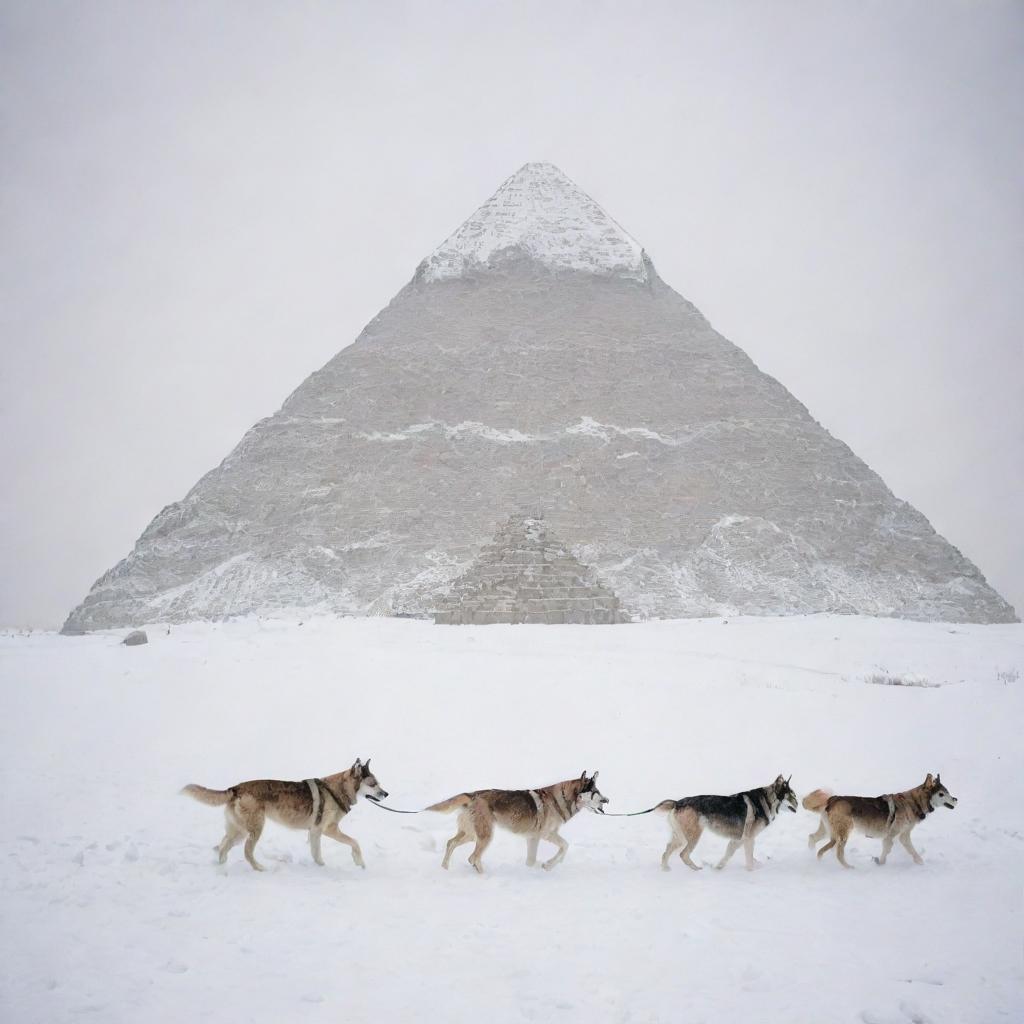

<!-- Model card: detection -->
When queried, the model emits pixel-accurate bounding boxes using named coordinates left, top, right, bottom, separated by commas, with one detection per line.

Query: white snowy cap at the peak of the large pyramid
left=417, top=164, right=649, bottom=282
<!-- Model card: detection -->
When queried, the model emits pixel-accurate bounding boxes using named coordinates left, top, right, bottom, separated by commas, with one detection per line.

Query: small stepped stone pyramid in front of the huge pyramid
left=434, top=514, right=626, bottom=626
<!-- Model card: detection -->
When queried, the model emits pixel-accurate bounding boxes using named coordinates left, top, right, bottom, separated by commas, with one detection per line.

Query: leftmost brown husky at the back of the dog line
left=181, top=759, right=387, bottom=871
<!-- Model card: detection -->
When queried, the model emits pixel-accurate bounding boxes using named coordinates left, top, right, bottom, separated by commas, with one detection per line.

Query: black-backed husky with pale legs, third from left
left=654, top=775, right=797, bottom=871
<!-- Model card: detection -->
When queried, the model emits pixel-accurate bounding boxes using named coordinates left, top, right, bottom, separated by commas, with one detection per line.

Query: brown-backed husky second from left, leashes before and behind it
left=426, top=771, right=608, bottom=874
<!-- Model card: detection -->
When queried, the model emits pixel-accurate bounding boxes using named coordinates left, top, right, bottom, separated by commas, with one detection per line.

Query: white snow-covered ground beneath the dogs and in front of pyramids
left=0, top=616, right=1024, bottom=1024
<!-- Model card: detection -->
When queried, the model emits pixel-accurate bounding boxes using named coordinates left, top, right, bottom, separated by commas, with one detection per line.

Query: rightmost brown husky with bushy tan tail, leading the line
left=804, top=772, right=956, bottom=867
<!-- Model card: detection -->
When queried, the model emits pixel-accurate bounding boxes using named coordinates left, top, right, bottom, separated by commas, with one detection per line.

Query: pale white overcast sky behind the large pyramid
left=0, top=0, right=1024, bottom=627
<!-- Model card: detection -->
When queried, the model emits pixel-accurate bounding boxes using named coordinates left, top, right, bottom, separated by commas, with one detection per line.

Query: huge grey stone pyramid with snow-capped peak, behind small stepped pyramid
left=65, top=164, right=1014, bottom=632
